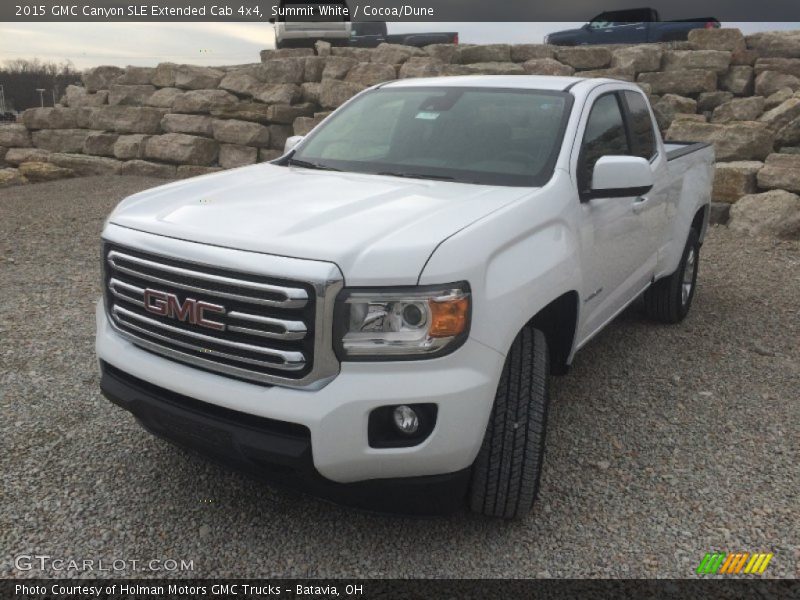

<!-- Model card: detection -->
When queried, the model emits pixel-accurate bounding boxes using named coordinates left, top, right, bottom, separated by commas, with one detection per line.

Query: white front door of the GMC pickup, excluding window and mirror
left=575, top=86, right=654, bottom=340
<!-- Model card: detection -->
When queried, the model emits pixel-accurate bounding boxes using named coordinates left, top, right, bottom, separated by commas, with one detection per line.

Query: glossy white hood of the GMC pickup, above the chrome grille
left=109, top=164, right=530, bottom=285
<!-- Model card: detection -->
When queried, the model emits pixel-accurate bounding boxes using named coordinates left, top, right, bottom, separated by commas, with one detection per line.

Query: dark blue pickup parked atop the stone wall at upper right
left=544, top=8, right=719, bottom=46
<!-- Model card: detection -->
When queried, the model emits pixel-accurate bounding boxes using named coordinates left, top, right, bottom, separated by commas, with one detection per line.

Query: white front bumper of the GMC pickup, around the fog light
left=96, top=303, right=504, bottom=483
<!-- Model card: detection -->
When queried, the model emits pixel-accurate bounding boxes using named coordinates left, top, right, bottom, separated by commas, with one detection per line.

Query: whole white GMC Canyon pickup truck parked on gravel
left=96, top=76, right=714, bottom=518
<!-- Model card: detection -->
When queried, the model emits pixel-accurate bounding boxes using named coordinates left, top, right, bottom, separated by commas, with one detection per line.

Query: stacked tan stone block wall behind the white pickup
left=0, top=29, right=800, bottom=237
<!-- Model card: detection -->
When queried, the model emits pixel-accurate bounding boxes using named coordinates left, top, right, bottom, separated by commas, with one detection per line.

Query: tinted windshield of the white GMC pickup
left=287, top=87, right=572, bottom=186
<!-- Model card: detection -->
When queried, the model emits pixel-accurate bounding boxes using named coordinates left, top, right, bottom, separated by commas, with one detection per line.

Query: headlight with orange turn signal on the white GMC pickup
left=336, top=282, right=471, bottom=360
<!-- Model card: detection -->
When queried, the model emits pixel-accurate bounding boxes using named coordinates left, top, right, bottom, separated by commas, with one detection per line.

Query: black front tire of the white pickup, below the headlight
left=470, top=327, right=550, bottom=519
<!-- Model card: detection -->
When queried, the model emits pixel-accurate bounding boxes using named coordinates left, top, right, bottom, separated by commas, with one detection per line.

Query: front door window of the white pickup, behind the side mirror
left=578, top=94, right=630, bottom=192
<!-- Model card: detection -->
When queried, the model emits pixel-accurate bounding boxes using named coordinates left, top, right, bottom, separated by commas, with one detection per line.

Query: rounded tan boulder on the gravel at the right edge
left=728, top=190, right=800, bottom=240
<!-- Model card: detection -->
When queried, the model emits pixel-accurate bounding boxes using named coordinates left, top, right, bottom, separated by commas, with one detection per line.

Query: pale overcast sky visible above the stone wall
left=0, top=22, right=800, bottom=69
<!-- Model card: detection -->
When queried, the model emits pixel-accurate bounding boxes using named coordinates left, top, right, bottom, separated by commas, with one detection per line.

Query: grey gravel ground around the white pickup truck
left=0, top=177, right=800, bottom=577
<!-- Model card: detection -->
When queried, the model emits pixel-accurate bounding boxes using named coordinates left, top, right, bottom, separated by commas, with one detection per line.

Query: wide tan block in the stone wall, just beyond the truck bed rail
left=666, top=119, right=775, bottom=161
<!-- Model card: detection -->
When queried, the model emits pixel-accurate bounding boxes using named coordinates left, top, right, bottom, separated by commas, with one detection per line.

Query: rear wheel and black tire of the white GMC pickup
left=644, top=229, right=700, bottom=323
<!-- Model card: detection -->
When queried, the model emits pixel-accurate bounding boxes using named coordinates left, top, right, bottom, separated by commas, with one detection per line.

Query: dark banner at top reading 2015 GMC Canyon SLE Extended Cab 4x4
left=0, top=0, right=800, bottom=22
